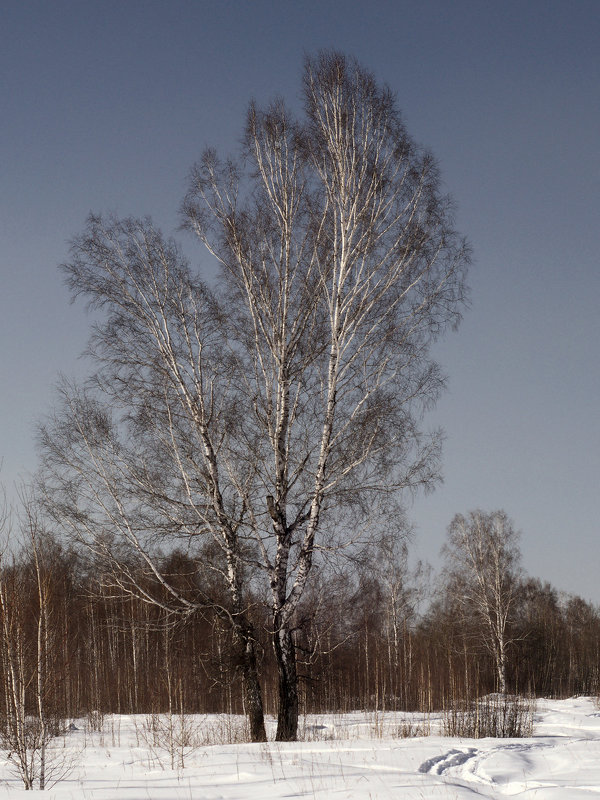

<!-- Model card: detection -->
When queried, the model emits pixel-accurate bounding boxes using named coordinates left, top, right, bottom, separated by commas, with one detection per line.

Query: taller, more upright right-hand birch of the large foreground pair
left=184, top=52, right=468, bottom=739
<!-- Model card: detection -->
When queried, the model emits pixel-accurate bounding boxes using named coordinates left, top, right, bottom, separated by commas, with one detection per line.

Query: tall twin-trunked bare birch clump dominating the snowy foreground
left=42, top=53, right=468, bottom=740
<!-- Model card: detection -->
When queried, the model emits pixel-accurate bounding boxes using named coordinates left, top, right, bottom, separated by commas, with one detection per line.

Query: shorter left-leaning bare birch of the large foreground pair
left=40, top=242, right=266, bottom=741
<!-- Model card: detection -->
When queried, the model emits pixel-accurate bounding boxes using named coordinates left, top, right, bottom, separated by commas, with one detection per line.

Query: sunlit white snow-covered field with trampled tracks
left=0, top=698, right=600, bottom=800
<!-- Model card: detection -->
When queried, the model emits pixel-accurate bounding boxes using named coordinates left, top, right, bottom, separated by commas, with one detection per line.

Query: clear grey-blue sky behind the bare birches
left=0, top=0, right=600, bottom=603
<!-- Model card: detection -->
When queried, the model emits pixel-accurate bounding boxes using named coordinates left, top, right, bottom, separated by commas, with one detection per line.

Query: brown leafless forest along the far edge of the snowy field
left=0, top=506, right=600, bottom=736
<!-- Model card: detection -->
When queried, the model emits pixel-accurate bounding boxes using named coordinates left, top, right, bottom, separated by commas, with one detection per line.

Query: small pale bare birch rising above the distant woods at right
left=443, top=511, right=520, bottom=694
